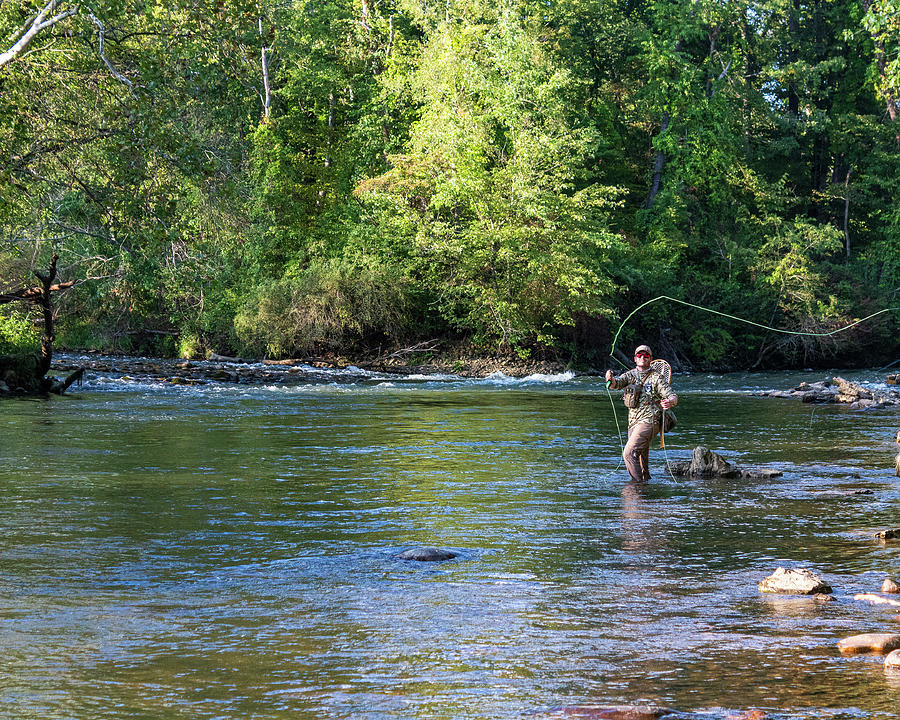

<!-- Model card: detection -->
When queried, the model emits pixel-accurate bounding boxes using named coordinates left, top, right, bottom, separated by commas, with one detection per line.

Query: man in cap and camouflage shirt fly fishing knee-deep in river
left=606, top=345, right=678, bottom=482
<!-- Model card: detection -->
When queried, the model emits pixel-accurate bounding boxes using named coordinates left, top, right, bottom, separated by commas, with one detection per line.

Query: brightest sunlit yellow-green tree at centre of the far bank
left=357, top=4, right=621, bottom=347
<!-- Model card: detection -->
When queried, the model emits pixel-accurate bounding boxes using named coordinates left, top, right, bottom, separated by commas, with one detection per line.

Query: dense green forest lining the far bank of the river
left=0, top=0, right=900, bottom=369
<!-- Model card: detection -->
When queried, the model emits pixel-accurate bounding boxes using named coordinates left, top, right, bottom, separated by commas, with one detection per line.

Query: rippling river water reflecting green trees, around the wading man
left=0, top=360, right=900, bottom=720
